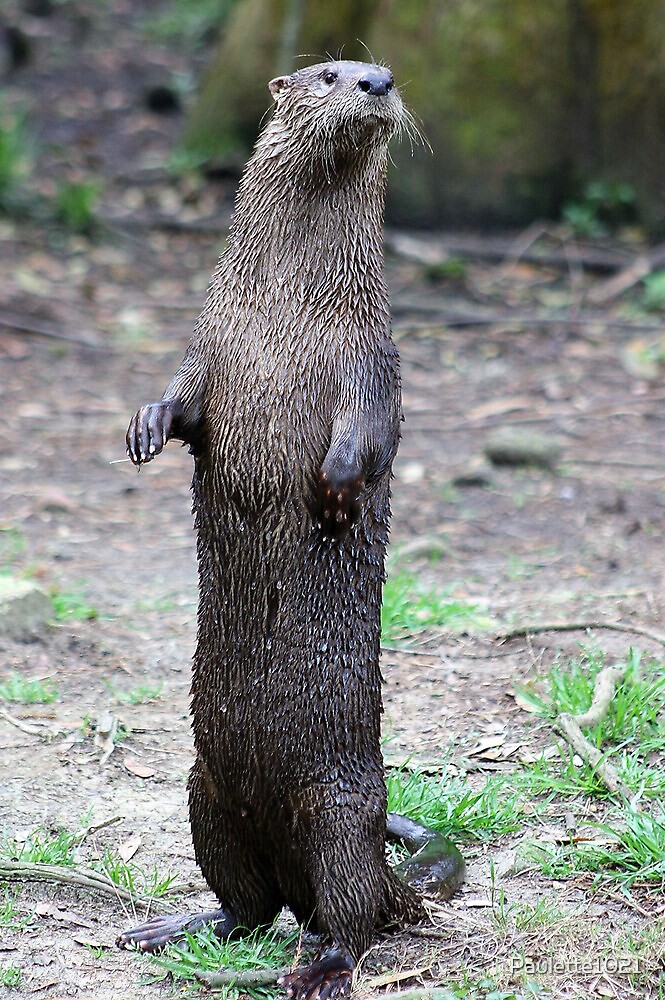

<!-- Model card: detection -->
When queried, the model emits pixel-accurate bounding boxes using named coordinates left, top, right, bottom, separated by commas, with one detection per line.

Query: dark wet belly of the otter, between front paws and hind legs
left=192, top=468, right=388, bottom=797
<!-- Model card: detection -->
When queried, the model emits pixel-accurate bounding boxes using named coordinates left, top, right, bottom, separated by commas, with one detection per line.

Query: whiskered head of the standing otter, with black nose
left=268, top=60, right=405, bottom=157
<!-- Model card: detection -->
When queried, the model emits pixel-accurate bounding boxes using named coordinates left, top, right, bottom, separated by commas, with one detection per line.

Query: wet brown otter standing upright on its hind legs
left=118, top=61, right=464, bottom=1000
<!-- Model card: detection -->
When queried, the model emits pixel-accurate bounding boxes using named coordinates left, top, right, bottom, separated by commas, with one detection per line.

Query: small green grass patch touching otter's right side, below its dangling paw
left=381, top=568, right=491, bottom=642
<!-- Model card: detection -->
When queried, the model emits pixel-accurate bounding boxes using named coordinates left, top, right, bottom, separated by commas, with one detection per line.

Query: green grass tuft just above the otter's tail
left=386, top=767, right=525, bottom=840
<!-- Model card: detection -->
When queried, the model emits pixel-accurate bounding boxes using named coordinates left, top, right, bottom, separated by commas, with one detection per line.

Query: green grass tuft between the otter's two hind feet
left=150, top=924, right=300, bottom=998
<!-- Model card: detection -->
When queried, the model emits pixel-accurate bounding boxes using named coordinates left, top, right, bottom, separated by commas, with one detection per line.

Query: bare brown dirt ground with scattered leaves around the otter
left=0, top=2, right=665, bottom=1000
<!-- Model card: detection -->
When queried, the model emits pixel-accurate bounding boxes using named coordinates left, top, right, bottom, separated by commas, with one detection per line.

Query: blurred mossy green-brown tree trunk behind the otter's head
left=185, top=0, right=665, bottom=229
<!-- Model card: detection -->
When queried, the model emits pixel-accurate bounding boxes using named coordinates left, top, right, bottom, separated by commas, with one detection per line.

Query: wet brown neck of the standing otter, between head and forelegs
left=222, top=125, right=387, bottom=314
